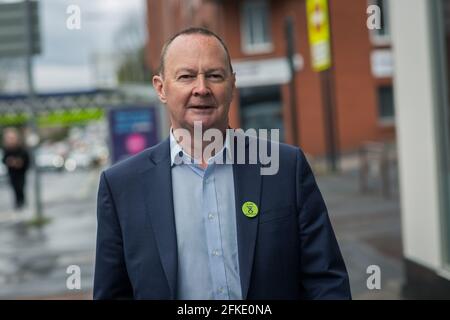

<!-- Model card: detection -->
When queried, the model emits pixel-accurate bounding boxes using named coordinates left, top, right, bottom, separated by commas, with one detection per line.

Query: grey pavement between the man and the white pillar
left=317, top=159, right=404, bottom=300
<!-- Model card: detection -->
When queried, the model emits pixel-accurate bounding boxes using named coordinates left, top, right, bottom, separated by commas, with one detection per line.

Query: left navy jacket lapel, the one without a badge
left=141, top=139, right=178, bottom=299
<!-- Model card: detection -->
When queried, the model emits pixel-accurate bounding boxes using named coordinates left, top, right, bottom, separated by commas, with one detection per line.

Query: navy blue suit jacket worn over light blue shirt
left=94, top=139, right=351, bottom=299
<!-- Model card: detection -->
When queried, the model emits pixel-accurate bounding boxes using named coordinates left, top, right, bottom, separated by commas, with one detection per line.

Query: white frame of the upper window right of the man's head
left=240, top=0, right=273, bottom=54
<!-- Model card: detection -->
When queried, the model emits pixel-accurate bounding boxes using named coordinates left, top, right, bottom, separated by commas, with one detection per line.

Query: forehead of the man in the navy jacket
left=165, top=34, right=227, bottom=71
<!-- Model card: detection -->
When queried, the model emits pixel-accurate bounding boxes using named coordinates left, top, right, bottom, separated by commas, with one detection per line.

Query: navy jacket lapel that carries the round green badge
left=233, top=137, right=261, bottom=299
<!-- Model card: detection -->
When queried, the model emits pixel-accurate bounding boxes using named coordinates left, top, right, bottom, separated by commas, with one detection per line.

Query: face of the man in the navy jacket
left=153, top=34, right=235, bottom=132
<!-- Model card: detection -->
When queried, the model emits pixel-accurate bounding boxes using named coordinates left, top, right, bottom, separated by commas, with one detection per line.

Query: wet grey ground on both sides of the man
left=0, top=152, right=403, bottom=299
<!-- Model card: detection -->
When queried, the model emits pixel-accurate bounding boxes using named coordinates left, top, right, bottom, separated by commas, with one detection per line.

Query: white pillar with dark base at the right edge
left=390, top=0, right=450, bottom=299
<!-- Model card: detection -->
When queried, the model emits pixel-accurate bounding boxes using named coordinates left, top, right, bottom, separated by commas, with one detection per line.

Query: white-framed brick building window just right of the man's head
left=241, top=0, right=273, bottom=54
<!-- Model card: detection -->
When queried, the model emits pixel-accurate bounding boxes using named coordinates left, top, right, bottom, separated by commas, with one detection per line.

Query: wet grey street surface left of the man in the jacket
left=0, top=170, right=98, bottom=299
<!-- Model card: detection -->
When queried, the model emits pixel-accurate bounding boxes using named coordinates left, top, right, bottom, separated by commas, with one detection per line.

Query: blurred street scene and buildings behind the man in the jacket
left=0, top=0, right=450, bottom=299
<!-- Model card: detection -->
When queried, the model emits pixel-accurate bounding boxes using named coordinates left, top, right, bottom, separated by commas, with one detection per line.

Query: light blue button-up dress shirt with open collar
left=170, top=129, right=242, bottom=300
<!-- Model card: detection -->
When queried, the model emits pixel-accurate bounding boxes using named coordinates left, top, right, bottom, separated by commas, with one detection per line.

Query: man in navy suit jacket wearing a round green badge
left=94, top=28, right=351, bottom=299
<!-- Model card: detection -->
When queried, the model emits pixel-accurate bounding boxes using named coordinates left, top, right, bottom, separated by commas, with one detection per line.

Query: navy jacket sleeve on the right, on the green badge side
left=296, top=149, right=351, bottom=299
